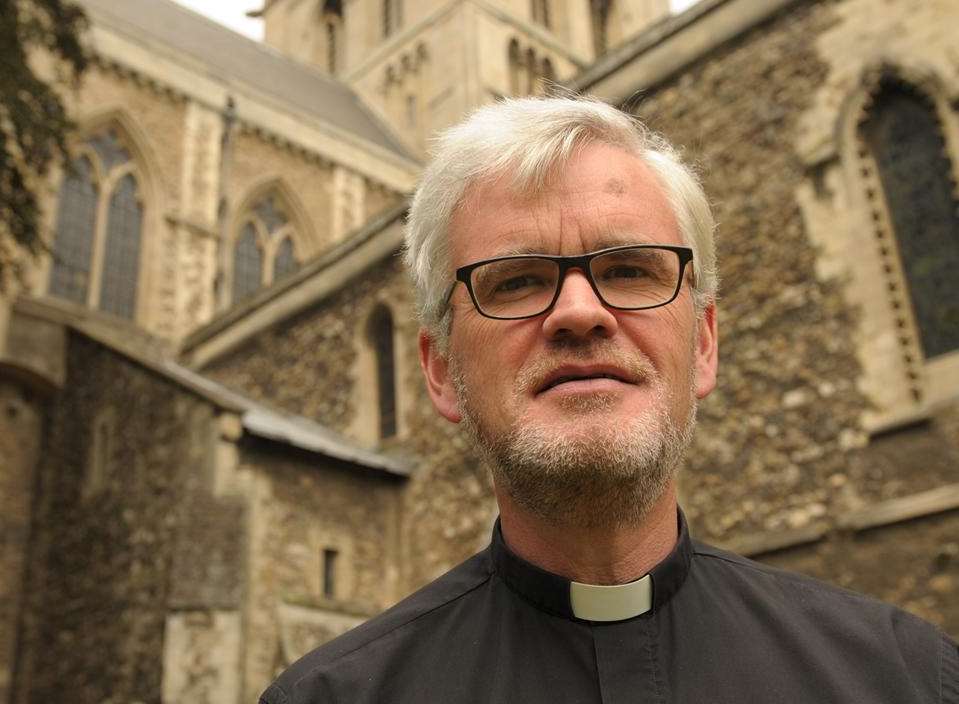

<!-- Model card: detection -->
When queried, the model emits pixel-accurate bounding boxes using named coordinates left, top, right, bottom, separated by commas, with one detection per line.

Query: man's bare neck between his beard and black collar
left=496, top=483, right=679, bottom=584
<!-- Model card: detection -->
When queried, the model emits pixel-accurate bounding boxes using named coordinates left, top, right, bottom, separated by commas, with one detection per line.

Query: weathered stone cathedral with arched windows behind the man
left=0, top=0, right=959, bottom=704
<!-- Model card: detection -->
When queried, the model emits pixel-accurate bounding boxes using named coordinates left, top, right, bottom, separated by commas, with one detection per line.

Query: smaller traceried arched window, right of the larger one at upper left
left=232, top=194, right=300, bottom=303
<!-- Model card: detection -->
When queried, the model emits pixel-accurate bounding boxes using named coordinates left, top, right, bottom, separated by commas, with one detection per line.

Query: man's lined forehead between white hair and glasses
left=450, top=144, right=683, bottom=267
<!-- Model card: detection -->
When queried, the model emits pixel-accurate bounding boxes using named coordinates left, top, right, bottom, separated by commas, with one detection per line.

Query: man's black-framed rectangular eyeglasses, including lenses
left=444, top=244, right=693, bottom=320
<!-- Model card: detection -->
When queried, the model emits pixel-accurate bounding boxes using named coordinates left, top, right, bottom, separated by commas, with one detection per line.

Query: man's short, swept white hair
left=405, top=97, right=719, bottom=344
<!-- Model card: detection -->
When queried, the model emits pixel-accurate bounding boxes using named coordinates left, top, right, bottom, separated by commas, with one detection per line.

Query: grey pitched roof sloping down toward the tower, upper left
left=78, top=0, right=413, bottom=159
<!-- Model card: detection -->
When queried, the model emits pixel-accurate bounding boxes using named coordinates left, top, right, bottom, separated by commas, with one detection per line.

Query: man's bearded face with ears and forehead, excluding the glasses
left=421, top=144, right=716, bottom=525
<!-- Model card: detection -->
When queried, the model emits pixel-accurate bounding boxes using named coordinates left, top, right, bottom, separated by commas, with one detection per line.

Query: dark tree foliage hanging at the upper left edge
left=0, top=0, right=88, bottom=283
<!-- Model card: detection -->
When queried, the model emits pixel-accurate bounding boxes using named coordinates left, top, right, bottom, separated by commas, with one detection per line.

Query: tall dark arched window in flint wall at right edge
left=860, top=79, right=959, bottom=358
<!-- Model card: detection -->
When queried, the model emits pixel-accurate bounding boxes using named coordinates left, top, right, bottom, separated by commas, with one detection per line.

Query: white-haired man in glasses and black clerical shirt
left=261, top=98, right=959, bottom=704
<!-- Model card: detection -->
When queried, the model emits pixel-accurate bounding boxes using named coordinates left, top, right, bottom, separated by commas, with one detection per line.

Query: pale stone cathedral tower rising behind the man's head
left=258, top=0, right=669, bottom=152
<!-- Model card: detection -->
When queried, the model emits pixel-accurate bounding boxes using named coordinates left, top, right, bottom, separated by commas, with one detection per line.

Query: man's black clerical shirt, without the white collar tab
left=260, top=516, right=959, bottom=704
